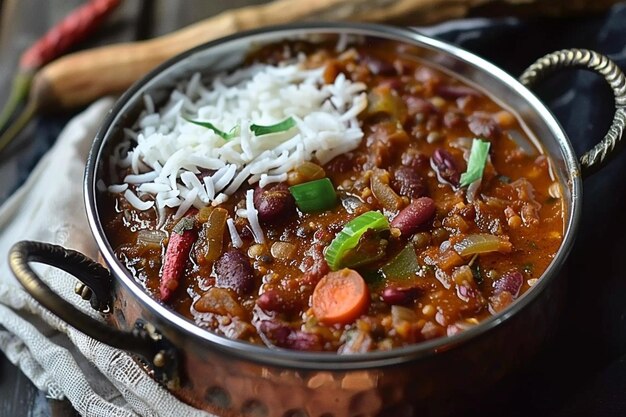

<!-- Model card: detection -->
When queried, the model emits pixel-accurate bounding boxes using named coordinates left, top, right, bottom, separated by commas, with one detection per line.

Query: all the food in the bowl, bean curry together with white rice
left=101, top=40, right=563, bottom=354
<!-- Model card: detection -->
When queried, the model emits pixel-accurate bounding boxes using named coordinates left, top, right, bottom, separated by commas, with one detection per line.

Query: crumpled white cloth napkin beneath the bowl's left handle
left=0, top=99, right=211, bottom=417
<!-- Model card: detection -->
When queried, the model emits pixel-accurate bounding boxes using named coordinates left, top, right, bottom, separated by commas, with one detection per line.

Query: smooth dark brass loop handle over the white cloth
left=9, top=241, right=177, bottom=383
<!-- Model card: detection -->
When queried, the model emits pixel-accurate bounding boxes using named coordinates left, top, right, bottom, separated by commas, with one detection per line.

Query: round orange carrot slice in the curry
left=311, top=268, right=369, bottom=324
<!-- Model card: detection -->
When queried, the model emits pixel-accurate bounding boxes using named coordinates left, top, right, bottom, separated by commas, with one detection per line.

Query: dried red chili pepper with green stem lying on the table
left=0, top=0, right=121, bottom=151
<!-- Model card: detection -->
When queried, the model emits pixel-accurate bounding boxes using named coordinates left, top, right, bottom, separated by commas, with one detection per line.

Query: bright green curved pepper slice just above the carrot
left=324, top=211, right=389, bottom=271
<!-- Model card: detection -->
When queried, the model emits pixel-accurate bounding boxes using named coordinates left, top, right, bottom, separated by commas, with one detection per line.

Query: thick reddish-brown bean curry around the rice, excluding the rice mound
left=101, top=41, right=563, bottom=353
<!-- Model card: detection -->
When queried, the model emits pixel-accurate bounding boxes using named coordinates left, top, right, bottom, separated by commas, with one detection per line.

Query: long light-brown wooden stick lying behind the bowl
left=31, top=0, right=616, bottom=109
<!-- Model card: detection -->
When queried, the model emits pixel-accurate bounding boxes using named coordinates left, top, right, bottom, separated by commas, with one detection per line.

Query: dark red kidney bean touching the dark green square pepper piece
left=254, top=183, right=296, bottom=223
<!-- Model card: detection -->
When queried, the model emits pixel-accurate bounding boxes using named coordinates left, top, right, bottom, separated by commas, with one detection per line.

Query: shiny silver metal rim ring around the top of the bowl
left=84, top=22, right=582, bottom=370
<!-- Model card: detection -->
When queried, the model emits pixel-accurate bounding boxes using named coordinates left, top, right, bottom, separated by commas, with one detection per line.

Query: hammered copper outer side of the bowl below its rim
left=109, top=266, right=563, bottom=417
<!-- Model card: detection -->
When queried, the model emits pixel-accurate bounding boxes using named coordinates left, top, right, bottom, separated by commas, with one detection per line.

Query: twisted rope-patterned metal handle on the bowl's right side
left=520, top=49, right=626, bottom=176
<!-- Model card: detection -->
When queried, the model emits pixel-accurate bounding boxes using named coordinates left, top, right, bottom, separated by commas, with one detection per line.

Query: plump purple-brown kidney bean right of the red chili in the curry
left=215, top=249, right=254, bottom=294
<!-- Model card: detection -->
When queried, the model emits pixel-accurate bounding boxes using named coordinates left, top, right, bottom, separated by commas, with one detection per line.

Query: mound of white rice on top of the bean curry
left=108, top=54, right=367, bottom=226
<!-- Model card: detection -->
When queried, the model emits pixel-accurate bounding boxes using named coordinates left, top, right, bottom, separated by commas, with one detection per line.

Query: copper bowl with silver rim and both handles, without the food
left=10, top=23, right=626, bottom=417
